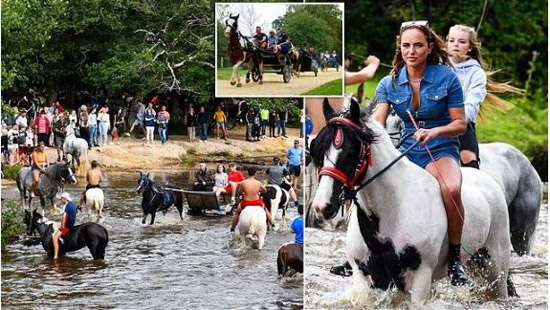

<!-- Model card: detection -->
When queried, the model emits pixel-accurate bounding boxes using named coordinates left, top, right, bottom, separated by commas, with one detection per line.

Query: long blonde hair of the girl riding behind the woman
left=447, top=24, right=524, bottom=114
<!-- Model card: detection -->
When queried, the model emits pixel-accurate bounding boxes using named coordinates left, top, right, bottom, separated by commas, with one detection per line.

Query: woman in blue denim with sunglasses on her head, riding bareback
left=374, top=21, right=467, bottom=285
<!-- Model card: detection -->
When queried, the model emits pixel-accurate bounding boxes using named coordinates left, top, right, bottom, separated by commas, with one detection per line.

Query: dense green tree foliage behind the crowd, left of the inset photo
left=2, top=0, right=214, bottom=106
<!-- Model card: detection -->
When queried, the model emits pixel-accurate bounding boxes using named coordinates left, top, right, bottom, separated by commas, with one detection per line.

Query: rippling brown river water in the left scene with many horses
left=2, top=173, right=302, bottom=309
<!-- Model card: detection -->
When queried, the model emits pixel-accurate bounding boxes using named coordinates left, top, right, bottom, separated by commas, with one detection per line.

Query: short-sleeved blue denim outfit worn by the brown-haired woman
left=376, top=64, right=464, bottom=149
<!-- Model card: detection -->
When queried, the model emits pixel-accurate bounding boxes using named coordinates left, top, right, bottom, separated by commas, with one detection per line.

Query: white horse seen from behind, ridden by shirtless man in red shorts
left=237, top=206, right=267, bottom=250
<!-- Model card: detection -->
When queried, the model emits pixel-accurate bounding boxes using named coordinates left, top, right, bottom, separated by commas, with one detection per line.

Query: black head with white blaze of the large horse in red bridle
left=310, top=98, right=375, bottom=219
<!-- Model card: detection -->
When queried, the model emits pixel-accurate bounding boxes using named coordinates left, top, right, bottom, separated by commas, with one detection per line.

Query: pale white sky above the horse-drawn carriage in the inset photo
left=216, top=3, right=343, bottom=35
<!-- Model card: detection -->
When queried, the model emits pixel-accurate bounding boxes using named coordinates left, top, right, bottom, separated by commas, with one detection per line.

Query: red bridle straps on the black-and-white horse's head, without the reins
left=319, top=117, right=372, bottom=190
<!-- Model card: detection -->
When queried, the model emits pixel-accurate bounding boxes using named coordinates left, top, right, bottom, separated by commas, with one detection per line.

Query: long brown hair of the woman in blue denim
left=390, top=25, right=452, bottom=85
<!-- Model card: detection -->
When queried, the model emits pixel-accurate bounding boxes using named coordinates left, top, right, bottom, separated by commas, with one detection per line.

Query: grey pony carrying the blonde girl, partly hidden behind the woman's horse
left=386, top=116, right=543, bottom=256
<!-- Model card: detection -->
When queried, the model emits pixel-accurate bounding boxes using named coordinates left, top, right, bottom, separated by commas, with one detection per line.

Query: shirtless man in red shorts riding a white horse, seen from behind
left=231, top=167, right=273, bottom=232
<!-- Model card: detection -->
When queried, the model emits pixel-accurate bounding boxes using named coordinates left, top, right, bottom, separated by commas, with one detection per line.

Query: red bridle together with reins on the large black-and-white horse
left=319, top=116, right=420, bottom=205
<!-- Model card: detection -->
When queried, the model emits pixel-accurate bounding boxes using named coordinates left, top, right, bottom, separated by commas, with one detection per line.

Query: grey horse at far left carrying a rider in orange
left=15, top=162, right=77, bottom=210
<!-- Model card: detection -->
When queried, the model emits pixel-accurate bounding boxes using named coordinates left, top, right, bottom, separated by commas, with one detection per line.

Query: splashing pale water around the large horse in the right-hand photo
left=304, top=203, right=548, bottom=309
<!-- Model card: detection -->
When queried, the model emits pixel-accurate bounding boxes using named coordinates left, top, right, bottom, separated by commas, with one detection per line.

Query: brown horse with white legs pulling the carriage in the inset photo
left=225, top=14, right=260, bottom=87
